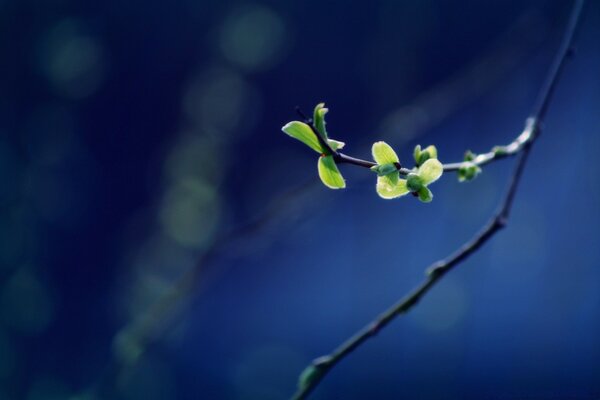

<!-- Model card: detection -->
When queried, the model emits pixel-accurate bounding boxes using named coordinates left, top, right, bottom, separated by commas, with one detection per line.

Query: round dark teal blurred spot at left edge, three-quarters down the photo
left=0, top=268, right=54, bottom=334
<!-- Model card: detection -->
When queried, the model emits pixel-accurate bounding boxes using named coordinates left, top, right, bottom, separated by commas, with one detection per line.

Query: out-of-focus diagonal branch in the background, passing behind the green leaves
left=97, top=3, right=564, bottom=396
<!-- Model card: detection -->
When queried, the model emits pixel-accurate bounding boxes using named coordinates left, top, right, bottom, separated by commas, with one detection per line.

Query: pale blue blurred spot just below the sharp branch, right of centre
left=409, top=279, right=468, bottom=332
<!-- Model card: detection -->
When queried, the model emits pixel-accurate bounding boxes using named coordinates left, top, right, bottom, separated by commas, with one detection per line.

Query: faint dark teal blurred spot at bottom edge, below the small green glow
left=118, top=357, right=173, bottom=400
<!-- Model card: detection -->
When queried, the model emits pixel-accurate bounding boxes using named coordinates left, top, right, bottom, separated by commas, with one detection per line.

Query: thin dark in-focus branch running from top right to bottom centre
left=293, top=0, right=585, bottom=399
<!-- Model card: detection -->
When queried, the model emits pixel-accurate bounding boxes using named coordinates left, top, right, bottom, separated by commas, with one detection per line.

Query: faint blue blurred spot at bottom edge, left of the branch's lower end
left=233, top=345, right=306, bottom=400
